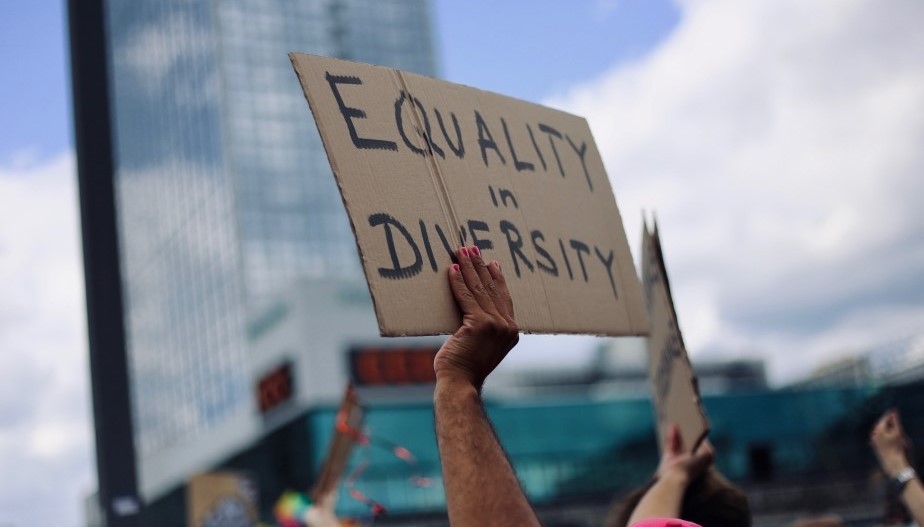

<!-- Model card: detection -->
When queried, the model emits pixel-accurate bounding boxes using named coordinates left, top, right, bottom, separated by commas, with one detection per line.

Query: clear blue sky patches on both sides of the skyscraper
left=0, top=0, right=679, bottom=160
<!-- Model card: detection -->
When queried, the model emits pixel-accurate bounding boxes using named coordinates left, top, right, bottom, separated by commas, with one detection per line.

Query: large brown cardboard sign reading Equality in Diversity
left=290, top=53, right=647, bottom=336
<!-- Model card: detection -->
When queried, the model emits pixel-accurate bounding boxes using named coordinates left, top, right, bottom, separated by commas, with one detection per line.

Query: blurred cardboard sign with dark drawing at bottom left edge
left=186, top=472, right=257, bottom=527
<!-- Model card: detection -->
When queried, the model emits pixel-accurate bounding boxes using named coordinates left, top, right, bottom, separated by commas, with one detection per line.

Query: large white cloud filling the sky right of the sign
left=551, top=0, right=924, bottom=380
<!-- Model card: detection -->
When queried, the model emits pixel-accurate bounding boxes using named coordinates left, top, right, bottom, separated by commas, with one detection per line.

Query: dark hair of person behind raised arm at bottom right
left=606, top=468, right=751, bottom=527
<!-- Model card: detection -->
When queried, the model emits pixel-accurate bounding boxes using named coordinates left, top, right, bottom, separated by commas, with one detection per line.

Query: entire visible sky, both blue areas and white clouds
left=0, top=0, right=924, bottom=527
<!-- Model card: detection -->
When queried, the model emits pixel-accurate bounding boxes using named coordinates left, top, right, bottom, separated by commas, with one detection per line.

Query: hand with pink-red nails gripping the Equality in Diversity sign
left=433, top=246, right=520, bottom=390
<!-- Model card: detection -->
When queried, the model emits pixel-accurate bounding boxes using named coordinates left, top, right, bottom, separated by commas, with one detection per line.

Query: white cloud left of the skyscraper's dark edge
left=0, top=153, right=95, bottom=526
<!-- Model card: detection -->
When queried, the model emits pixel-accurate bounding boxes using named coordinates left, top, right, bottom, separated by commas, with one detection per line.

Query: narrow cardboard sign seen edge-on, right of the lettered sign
left=642, top=223, right=709, bottom=451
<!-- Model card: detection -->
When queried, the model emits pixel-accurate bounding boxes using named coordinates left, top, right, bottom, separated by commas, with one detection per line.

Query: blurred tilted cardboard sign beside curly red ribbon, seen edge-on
left=309, top=384, right=364, bottom=502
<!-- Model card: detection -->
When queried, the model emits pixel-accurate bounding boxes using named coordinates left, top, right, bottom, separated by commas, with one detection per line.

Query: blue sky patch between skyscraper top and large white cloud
left=434, top=0, right=679, bottom=102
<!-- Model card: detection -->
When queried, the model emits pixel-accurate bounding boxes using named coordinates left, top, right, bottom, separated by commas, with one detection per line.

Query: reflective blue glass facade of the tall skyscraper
left=105, top=0, right=435, bottom=500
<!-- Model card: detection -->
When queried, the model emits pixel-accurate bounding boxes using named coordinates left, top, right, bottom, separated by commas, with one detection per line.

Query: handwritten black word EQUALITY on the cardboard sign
left=325, top=72, right=594, bottom=192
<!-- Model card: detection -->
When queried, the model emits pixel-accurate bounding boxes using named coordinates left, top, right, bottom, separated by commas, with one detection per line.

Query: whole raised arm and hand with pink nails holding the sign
left=433, top=247, right=539, bottom=527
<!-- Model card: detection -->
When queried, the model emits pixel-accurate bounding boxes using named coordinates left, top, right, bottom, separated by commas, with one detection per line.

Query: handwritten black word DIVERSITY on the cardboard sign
left=369, top=212, right=619, bottom=299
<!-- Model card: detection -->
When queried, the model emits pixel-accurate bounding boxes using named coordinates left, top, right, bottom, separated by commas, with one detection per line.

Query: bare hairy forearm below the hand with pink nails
left=434, top=379, right=539, bottom=527
